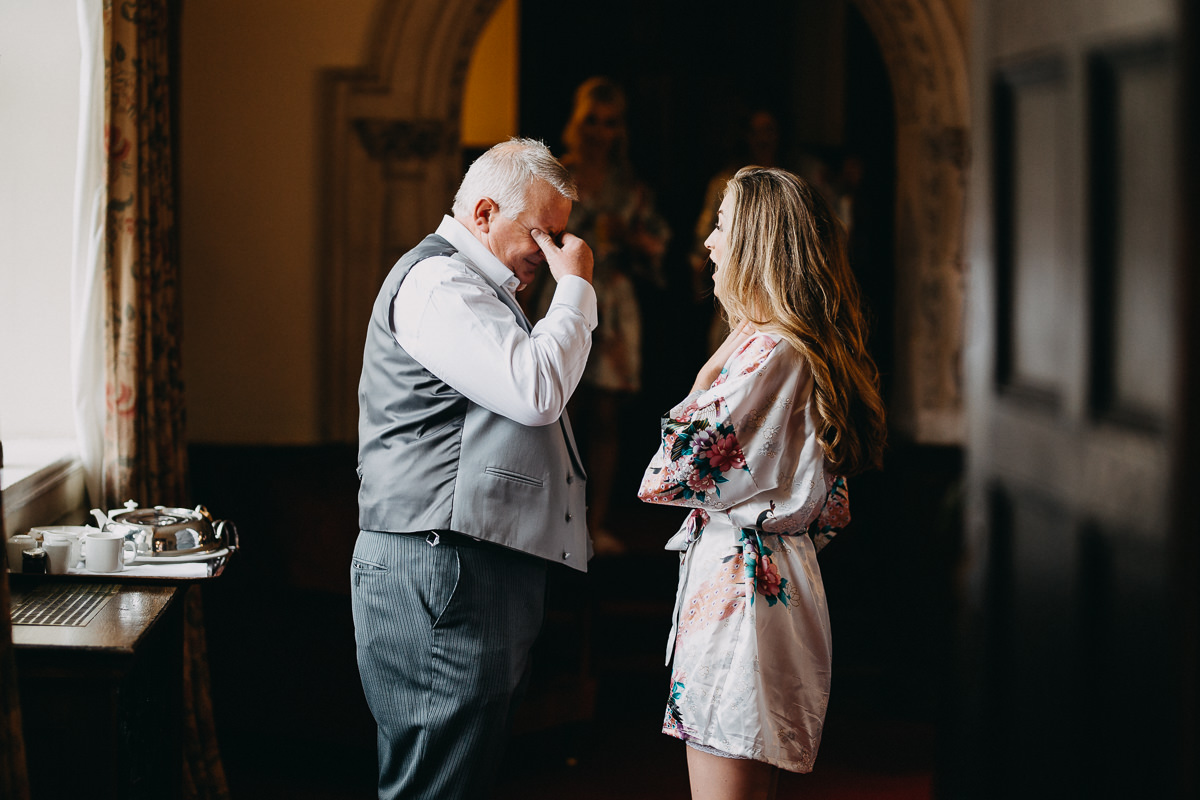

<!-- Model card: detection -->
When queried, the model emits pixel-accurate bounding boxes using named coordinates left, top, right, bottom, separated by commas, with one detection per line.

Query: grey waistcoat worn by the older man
left=359, top=235, right=588, bottom=571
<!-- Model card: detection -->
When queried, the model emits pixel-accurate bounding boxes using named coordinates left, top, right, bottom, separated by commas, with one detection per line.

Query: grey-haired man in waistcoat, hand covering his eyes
left=350, top=139, right=596, bottom=800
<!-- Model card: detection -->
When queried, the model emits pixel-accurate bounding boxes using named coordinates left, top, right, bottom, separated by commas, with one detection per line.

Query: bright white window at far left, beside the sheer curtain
left=0, top=0, right=79, bottom=525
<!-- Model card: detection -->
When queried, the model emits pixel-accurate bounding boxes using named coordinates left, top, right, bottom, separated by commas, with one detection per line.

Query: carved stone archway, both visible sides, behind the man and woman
left=320, top=0, right=968, bottom=444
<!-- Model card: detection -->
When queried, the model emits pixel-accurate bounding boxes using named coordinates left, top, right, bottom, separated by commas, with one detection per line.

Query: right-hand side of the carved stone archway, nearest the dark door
left=852, top=0, right=970, bottom=445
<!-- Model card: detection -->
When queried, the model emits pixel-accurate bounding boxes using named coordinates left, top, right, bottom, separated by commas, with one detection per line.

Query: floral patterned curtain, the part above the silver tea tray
left=102, top=0, right=187, bottom=509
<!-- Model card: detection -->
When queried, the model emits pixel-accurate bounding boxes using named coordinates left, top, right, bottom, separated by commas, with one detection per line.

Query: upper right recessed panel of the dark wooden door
left=1088, top=40, right=1176, bottom=431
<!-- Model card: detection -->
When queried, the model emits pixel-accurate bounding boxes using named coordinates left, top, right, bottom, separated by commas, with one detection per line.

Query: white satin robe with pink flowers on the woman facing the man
left=638, top=332, right=850, bottom=772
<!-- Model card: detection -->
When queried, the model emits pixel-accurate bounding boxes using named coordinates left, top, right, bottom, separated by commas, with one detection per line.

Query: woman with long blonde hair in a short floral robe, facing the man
left=638, top=167, right=886, bottom=800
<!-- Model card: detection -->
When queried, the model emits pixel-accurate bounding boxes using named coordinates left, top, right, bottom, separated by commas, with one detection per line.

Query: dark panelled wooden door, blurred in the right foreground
left=941, top=0, right=1200, bottom=799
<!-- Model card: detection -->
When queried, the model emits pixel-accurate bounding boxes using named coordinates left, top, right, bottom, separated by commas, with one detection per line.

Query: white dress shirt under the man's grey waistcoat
left=391, top=217, right=596, bottom=426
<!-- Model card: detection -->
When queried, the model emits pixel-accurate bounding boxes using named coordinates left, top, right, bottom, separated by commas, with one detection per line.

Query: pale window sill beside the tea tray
left=0, top=439, right=86, bottom=536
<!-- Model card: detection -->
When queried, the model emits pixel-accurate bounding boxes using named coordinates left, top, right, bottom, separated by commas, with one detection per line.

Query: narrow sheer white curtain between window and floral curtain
left=71, top=0, right=108, bottom=513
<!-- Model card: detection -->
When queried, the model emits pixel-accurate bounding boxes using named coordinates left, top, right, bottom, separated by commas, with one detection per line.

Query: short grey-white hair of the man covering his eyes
left=452, top=139, right=580, bottom=219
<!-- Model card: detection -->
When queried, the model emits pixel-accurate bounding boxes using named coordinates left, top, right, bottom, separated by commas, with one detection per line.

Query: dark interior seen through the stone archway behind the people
left=520, top=0, right=895, bottom=407
